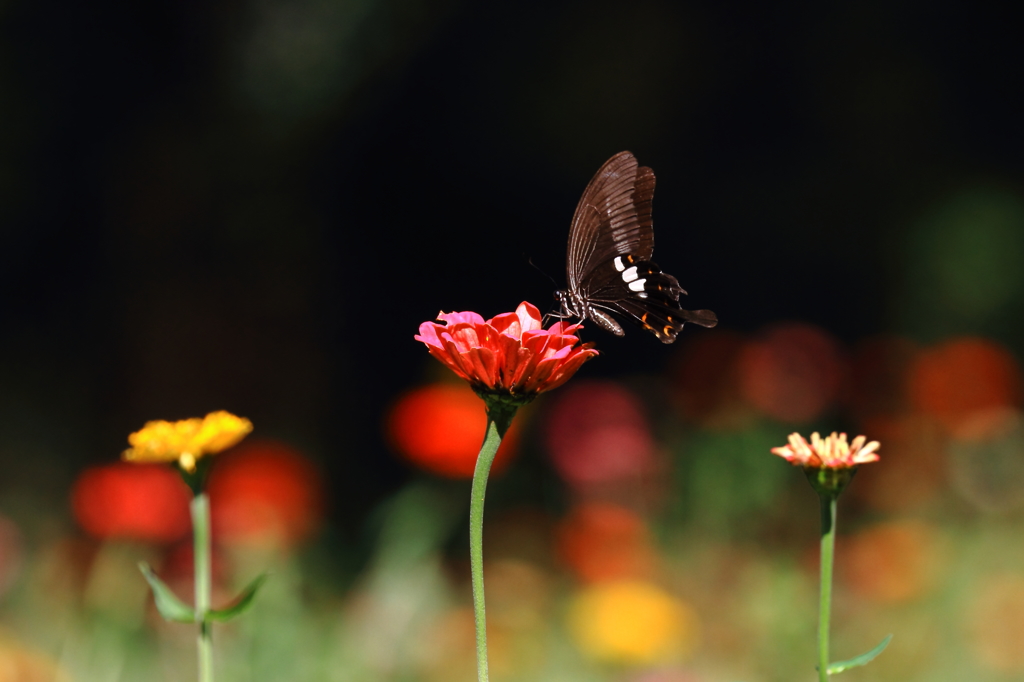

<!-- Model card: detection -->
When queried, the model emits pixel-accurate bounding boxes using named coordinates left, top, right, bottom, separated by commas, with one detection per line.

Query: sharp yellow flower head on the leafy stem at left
left=121, top=410, right=253, bottom=472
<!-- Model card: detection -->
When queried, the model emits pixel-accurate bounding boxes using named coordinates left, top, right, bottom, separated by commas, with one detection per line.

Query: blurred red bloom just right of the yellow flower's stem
left=207, top=440, right=324, bottom=546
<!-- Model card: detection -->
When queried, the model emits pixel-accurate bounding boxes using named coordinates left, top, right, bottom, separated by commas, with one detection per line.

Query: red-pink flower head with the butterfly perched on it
left=415, top=301, right=597, bottom=398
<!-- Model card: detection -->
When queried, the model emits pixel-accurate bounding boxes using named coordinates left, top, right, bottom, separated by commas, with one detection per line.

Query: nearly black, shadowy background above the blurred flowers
left=0, top=0, right=1024, bottom=521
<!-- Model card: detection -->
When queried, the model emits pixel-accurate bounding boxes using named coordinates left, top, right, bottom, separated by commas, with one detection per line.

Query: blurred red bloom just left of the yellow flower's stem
left=71, top=462, right=191, bottom=543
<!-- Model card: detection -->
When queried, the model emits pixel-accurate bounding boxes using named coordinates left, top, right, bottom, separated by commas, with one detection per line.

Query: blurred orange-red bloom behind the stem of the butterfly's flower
left=387, top=384, right=518, bottom=478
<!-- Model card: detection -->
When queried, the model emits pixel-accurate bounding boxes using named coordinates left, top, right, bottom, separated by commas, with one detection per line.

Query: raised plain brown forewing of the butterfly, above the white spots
left=565, top=152, right=654, bottom=291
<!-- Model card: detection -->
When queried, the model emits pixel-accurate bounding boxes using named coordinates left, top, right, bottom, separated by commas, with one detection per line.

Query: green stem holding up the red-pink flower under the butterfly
left=469, top=400, right=517, bottom=682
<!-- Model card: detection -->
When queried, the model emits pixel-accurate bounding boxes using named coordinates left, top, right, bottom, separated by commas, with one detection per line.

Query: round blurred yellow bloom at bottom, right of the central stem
left=568, top=581, right=697, bottom=665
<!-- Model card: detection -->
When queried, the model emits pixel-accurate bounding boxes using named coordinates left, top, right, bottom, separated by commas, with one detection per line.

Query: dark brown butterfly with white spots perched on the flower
left=555, top=152, right=718, bottom=343
